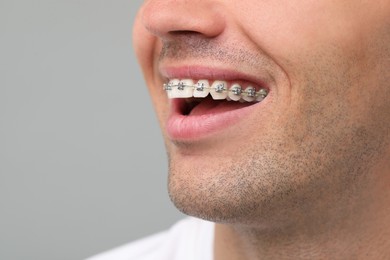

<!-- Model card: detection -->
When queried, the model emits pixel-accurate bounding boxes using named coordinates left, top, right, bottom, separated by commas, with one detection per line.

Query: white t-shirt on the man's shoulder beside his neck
left=87, top=217, right=214, bottom=260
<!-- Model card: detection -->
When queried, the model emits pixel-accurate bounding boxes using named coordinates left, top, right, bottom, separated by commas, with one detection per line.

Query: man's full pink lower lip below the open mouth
left=166, top=99, right=265, bottom=141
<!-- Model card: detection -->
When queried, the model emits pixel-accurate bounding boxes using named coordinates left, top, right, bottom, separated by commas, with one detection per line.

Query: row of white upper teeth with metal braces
left=164, top=79, right=268, bottom=102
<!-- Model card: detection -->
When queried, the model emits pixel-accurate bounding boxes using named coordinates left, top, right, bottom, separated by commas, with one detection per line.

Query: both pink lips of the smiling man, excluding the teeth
left=160, top=67, right=269, bottom=141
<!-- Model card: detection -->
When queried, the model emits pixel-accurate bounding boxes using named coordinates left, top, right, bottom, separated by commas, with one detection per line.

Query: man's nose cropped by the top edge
left=141, top=0, right=225, bottom=40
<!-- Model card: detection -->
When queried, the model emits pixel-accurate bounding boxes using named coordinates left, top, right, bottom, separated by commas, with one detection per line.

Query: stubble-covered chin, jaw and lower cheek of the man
left=167, top=46, right=390, bottom=230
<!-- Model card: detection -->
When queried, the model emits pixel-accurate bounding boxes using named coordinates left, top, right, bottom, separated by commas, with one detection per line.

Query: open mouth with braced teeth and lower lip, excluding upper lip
left=164, top=79, right=269, bottom=140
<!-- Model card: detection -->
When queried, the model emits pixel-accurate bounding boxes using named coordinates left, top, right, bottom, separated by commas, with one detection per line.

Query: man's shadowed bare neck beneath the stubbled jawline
left=215, top=172, right=390, bottom=260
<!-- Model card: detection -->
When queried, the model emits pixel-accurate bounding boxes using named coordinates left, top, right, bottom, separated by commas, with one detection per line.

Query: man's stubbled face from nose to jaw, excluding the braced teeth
left=134, top=0, right=390, bottom=224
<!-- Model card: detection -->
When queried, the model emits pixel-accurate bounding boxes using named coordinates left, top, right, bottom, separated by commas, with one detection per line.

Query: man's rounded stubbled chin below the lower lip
left=168, top=156, right=274, bottom=224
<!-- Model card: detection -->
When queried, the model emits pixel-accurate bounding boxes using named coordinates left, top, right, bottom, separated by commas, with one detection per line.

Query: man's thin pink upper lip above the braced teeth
left=160, top=65, right=270, bottom=89
